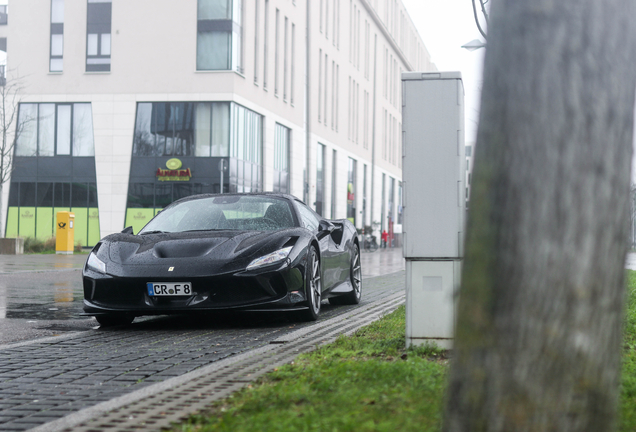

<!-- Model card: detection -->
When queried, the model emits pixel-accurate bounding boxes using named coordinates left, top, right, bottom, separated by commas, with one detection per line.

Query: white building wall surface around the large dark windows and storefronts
left=0, top=0, right=435, bottom=241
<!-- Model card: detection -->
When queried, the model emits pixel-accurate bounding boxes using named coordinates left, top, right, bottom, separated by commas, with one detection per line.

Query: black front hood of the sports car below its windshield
left=98, top=228, right=306, bottom=276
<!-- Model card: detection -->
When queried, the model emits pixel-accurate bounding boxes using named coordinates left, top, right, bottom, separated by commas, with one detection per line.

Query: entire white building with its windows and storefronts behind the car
left=0, top=0, right=435, bottom=247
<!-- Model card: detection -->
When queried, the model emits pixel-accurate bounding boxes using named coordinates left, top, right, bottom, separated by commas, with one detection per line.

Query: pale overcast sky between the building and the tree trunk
left=402, top=0, right=484, bottom=145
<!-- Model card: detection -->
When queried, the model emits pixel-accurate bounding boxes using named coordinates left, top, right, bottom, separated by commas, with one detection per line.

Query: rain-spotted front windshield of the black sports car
left=139, top=195, right=296, bottom=234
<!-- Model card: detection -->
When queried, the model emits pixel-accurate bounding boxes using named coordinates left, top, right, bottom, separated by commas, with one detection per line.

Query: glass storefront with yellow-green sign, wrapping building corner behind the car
left=125, top=102, right=263, bottom=233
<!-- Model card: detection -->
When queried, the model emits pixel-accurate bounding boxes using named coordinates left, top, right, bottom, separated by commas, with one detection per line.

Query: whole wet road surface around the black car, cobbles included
left=0, top=250, right=404, bottom=431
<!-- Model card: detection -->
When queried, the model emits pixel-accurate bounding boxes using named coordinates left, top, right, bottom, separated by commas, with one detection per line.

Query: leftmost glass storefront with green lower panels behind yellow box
left=5, top=103, right=100, bottom=247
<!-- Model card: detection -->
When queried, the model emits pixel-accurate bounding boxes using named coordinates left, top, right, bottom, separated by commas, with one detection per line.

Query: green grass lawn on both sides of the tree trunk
left=174, top=271, right=636, bottom=432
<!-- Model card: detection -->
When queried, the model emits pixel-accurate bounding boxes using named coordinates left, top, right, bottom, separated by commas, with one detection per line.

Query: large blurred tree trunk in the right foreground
left=444, top=0, right=636, bottom=432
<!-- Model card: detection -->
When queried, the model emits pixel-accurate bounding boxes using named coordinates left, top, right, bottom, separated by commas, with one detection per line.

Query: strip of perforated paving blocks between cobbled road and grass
left=39, top=293, right=404, bottom=432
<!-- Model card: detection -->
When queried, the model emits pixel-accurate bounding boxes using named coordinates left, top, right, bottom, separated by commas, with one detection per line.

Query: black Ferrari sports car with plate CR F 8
left=82, top=193, right=362, bottom=325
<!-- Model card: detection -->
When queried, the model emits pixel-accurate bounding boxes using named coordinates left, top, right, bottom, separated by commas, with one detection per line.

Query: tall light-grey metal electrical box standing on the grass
left=402, top=72, right=466, bottom=348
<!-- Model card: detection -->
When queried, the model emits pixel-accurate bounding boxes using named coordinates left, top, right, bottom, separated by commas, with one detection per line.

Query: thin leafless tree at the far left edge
left=0, top=72, right=27, bottom=238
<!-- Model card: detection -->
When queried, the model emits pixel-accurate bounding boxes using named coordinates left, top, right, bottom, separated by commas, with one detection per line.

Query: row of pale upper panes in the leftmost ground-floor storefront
left=15, top=103, right=95, bottom=156
